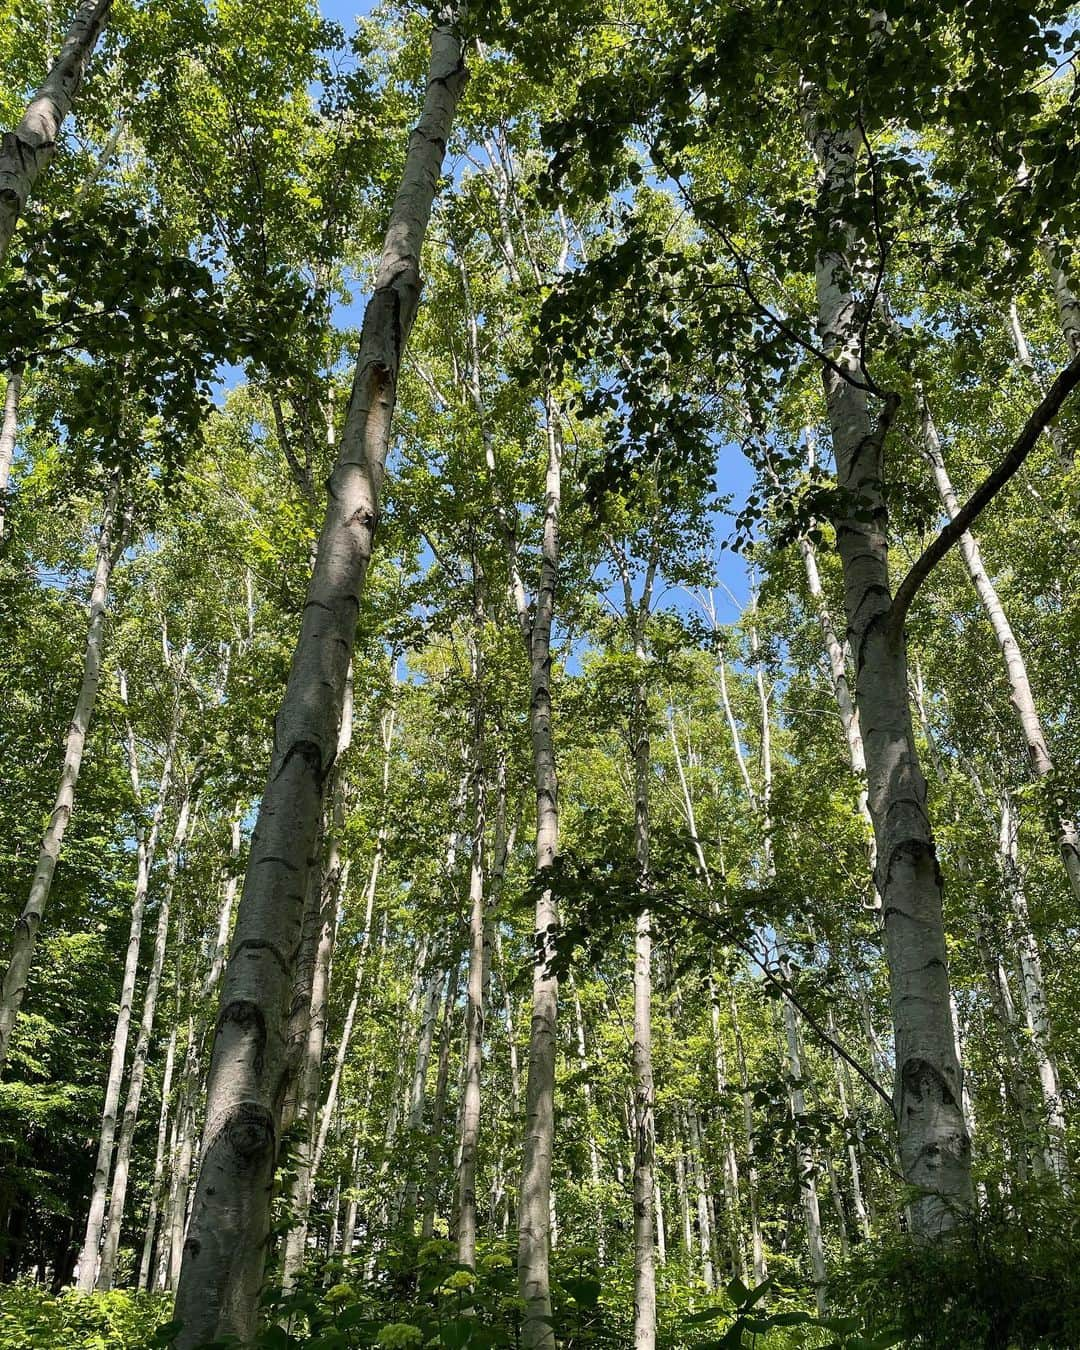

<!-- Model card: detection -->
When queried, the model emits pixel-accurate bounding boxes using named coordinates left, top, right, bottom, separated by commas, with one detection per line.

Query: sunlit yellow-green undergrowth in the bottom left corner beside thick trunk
left=0, top=1280, right=173, bottom=1350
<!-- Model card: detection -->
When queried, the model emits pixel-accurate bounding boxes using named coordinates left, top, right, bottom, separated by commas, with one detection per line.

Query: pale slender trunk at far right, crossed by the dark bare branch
left=919, top=394, right=1080, bottom=902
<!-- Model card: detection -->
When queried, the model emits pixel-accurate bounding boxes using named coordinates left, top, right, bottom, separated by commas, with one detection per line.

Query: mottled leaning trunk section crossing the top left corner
left=0, top=0, right=112, bottom=262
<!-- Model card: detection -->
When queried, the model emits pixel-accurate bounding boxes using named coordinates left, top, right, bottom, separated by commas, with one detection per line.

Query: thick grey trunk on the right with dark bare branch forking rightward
left=806, top=108, right=972, bottom=1235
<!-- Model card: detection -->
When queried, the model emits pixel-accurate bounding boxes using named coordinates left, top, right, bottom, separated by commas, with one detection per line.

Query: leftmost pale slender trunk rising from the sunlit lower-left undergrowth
left=78, top=672, right=180, bottom=1293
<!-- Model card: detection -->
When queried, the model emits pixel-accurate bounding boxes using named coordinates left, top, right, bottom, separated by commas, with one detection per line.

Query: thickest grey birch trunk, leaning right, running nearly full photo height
left=176, top=11, right=466, bottom=1350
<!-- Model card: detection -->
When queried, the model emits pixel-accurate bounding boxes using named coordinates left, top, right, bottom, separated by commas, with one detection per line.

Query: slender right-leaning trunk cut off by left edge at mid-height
left=0, top=485, right=119, bottom=1072
